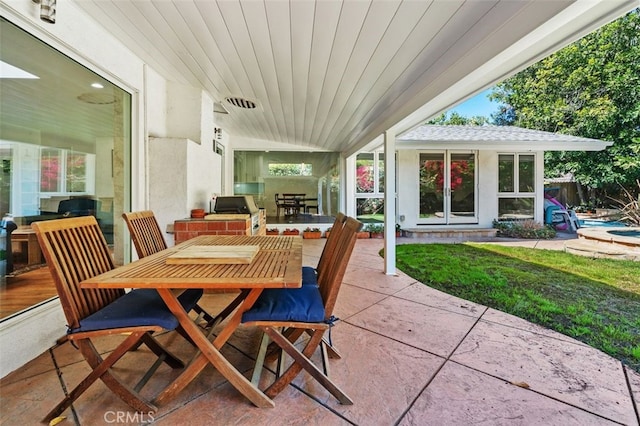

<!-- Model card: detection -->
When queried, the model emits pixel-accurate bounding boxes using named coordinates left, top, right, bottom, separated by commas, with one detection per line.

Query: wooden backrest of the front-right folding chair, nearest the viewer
left=318, top=217, right=362, bottom=319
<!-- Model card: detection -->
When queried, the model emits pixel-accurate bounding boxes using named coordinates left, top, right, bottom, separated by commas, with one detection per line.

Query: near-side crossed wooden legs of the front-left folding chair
left=43, top=332, right=157, bottom=423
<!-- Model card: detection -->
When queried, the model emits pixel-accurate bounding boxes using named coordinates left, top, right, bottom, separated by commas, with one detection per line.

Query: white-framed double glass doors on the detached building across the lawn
left=418, top=151, right=478, bottom=224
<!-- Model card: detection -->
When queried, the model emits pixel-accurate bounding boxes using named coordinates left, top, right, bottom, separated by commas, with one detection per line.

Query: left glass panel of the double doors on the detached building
left=418, top=153, right=446, bottom=223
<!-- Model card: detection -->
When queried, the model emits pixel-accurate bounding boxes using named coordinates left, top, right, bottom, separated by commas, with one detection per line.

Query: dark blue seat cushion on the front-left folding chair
left=69, top=289, right=203, bottom=333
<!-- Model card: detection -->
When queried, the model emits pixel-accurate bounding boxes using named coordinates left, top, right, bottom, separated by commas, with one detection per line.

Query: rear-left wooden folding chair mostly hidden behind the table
left=122, top=210, right=214, bottom=327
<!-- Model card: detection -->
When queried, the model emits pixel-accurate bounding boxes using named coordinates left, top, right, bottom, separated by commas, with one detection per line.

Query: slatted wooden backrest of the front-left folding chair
left=31, top=216, right=124, bottom=329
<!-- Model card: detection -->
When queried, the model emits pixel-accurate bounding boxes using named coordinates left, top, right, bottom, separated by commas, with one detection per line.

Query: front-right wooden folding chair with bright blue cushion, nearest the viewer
left=242, top=218, right=362, bottom=404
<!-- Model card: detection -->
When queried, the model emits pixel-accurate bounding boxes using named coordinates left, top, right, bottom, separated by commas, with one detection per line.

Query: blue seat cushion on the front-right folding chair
left=242, top=285, right=324, bottom=322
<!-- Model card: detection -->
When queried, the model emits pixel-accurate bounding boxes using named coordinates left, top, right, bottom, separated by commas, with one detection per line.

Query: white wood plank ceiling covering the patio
left=3, top=0, right=635, bottom=153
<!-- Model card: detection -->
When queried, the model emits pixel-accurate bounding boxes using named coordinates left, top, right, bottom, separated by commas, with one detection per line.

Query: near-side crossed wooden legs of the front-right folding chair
left=263, top=327, right=353, bottom=405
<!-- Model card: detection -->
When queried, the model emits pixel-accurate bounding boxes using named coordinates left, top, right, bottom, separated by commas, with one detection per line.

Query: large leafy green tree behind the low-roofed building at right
left=491, top=9, right=640, bottom=208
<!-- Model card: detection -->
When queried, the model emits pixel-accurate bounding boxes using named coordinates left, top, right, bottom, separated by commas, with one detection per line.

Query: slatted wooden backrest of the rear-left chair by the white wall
left=122, top=210, right=167, bottom=259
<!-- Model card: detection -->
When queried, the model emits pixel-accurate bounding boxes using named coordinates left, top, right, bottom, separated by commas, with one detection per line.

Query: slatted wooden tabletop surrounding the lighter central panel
left=82, top=235, right=302, bottom=289
